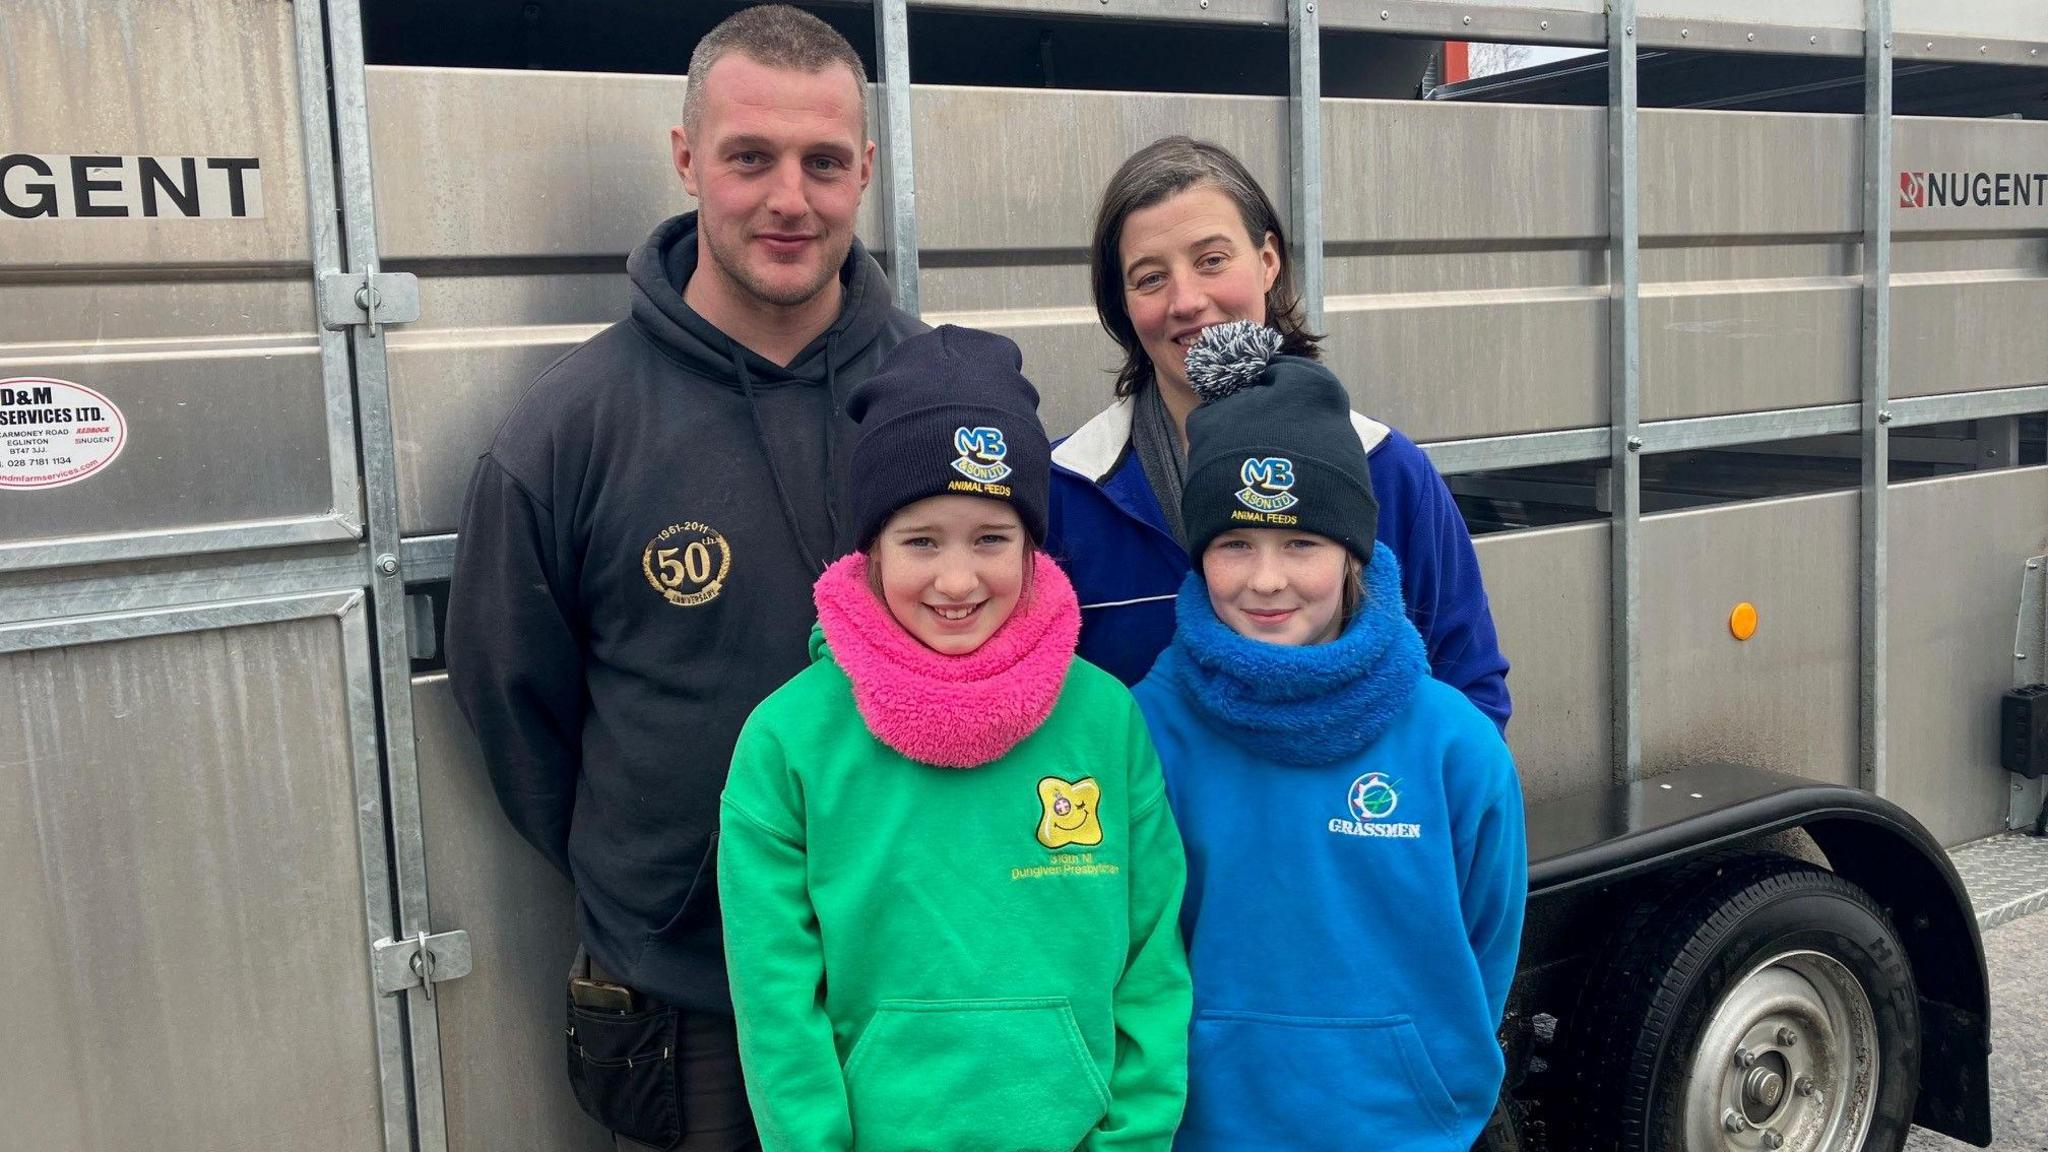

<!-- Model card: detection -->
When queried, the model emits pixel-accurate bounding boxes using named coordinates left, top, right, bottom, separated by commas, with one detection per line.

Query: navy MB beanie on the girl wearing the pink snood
left=846, top=324, right=1053, bottom=549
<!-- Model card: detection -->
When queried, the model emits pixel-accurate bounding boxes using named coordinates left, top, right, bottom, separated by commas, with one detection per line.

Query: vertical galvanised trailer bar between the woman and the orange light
left=1608, top=0, right=1642, bottom=783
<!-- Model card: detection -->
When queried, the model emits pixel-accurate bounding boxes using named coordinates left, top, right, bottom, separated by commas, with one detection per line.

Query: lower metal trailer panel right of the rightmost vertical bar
left=1886, top=467, right=2048, bottom=845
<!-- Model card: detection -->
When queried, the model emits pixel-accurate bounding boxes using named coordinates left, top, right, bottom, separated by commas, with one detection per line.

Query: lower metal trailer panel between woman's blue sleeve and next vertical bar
left=1473, top=523, right=1612, bottom=804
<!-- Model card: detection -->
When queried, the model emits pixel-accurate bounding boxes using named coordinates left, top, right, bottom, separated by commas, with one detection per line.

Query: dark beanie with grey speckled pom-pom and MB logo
left=1180, top=320, right=1380, bottom=564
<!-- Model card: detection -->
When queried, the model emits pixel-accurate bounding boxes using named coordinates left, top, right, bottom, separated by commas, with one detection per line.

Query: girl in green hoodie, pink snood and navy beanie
left=719, top=326, right=1190, bottom=1152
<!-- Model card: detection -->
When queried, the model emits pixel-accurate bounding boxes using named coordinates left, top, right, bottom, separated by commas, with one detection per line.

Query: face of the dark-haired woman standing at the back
left=1116, top=184, right=1280, bottom=389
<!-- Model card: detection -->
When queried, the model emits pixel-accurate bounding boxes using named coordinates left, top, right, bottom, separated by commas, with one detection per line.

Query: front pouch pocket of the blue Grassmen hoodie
left=1176, top=1013, right=1458, bottom=1150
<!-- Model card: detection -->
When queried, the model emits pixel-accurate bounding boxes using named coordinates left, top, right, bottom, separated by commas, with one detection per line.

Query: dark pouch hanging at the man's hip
left=567, top=953, right=682, bottom=1150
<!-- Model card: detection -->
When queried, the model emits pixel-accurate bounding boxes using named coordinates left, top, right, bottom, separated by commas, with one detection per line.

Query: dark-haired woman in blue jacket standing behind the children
left=1047, top=135, right=1509, bottom=730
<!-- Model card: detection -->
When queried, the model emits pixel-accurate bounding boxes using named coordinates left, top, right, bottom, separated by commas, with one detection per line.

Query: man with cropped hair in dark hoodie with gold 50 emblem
left=446, top=6, right=924, bottom=1152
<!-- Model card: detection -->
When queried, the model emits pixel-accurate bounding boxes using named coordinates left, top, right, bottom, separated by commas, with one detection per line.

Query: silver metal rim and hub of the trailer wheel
left=1681, top=951, right=1878, bottom=1152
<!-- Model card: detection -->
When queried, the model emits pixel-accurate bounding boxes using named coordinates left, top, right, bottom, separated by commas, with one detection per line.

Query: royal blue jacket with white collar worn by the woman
left=1047, top=400, right=1513, bottom=732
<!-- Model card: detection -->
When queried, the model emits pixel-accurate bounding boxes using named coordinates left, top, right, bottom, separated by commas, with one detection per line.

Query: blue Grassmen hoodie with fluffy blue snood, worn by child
left=1137, top=545, right=1528, bottom=1152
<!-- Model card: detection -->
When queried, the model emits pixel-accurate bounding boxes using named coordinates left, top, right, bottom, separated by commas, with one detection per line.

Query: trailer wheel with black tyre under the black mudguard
left=1567, top=857, right=1919, bottom=1152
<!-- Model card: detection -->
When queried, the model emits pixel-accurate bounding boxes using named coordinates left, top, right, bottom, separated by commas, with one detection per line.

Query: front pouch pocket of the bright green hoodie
left=846, top=996, right=1110, bottom=1152
